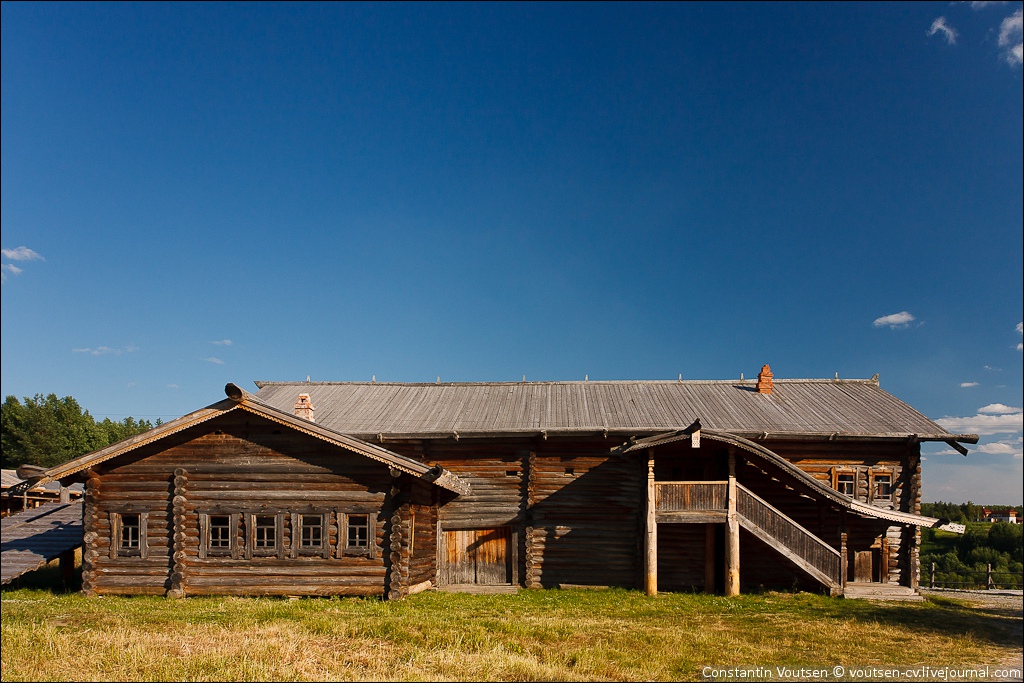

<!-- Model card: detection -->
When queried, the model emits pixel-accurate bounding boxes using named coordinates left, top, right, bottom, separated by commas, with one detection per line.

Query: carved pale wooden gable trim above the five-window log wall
left=11, top=384, right=470, bottom=494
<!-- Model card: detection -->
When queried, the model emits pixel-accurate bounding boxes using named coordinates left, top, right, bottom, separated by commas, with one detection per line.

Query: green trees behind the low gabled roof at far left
left=0, top=393, right=162, bottom=469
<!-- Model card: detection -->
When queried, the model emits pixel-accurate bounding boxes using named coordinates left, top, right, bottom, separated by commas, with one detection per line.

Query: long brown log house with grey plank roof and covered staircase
left=24, top=366, right=978, bottom=599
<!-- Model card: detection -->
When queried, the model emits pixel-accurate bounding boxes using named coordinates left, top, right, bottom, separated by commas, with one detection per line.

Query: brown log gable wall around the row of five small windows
left=83, top=415, right=397, bottom=595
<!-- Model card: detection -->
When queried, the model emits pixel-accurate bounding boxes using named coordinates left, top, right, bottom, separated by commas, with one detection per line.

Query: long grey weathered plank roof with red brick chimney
left=256, top=379, right=977, bottom=442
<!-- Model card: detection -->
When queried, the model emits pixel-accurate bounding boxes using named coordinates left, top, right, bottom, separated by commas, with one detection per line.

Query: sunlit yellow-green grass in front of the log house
left=0, top=589, right=1021, bottom=681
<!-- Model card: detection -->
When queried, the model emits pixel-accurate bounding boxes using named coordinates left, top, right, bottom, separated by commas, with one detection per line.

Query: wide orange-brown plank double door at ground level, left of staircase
left=440, top=526, right=512, bottom=586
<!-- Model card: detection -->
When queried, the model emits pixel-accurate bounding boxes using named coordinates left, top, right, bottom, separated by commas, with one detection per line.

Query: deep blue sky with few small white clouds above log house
left=0, top=3, right=1024, bottom=504
